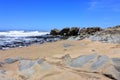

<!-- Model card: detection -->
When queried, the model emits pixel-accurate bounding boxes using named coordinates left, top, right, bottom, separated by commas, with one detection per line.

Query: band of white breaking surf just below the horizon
left=0, top=31, right=49, bottom=37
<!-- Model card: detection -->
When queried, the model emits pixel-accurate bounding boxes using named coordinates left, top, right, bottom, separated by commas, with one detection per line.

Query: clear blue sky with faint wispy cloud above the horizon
left=0, top=0, right=120, bottom=31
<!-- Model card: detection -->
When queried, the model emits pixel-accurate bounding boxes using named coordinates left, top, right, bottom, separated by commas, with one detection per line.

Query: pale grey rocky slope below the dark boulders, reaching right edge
left=68, top=29, right=120, bottom=43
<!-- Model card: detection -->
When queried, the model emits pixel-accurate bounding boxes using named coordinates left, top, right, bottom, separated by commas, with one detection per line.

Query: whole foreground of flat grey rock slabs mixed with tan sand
left=0, top=54, right=120, bottom=80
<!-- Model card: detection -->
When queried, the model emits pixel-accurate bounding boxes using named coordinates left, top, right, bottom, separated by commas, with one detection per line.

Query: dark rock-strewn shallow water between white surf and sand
left=0, top=35, right=61, bottom=50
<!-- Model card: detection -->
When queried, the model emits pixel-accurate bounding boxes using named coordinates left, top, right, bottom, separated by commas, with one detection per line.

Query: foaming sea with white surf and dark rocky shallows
left=0, top=31, right=60, bottom=50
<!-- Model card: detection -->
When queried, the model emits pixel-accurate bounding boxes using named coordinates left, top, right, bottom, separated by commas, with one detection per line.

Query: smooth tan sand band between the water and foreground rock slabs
left=0, top=39, right=120, bottom=59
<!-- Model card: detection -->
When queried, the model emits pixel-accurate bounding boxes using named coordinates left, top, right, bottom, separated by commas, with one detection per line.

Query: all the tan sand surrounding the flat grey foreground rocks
left=0, top=39, right=120, bottom=80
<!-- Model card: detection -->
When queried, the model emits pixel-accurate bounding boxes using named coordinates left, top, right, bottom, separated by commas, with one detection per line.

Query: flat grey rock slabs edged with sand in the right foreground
left=63, top=54, right=120, bottom=80
